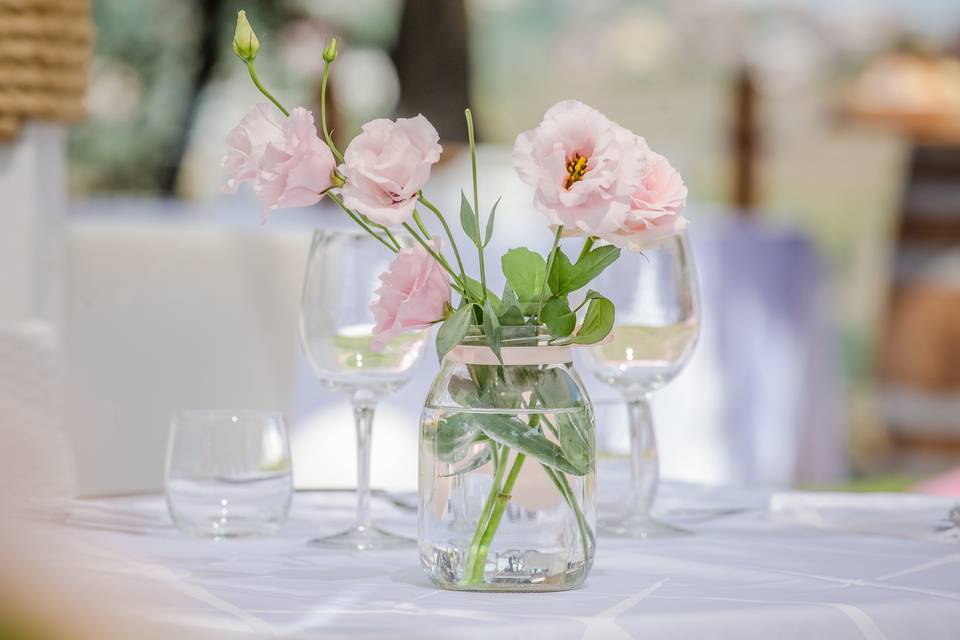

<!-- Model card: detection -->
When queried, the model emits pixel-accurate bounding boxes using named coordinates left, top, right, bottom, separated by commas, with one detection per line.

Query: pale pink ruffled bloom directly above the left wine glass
left=340, top=115, right=443, bottom=226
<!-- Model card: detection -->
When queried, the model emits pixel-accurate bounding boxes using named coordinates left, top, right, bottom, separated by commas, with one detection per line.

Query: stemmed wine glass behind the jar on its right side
left=585, top=234, right=700, bottom=538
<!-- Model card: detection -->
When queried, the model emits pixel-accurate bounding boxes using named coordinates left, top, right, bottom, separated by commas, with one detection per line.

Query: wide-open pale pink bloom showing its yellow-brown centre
left=513, top=100, right=646, bottom=236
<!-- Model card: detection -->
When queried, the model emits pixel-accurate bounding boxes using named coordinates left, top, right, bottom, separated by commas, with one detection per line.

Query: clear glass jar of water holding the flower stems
left=419, top=328, right=596, bottom=591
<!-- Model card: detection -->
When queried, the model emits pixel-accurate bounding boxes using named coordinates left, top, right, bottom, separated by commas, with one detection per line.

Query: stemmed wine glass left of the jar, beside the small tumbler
left=300, top=229, right=426, bottom=550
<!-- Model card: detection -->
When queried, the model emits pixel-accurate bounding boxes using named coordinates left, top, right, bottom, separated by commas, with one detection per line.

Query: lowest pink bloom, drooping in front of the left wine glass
left=370, top=237, right=451, bottom=351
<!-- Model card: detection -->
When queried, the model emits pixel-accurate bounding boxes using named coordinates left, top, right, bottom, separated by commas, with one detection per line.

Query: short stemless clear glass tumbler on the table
left=166, top=410, right=293, bottom=538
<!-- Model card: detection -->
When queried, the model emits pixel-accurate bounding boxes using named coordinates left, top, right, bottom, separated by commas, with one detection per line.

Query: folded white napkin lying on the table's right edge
left=768, top=491, right=960, bottom=541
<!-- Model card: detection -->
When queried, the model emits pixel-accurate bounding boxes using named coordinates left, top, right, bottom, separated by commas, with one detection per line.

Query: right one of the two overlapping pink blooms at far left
left=254, top=107, right=336, bottom=218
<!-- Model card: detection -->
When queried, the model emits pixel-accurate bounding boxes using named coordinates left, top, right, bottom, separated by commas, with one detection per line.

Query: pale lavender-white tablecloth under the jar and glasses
left=22, top=485, right=960, bottom=640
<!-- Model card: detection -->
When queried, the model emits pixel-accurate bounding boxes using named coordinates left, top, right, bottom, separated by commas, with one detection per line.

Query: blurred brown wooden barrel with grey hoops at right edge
left=879, top=144, right=960, bottom=470
